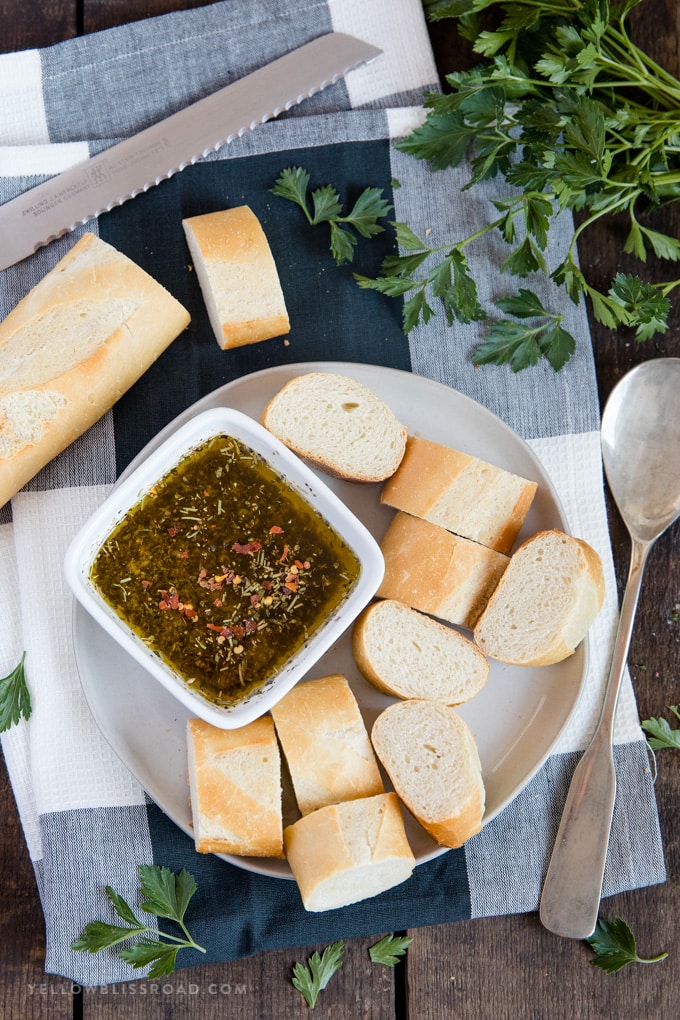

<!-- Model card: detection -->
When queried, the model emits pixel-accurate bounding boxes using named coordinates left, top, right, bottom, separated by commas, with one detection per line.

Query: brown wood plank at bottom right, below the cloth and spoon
left=407, top=890, right=680, bottom=1020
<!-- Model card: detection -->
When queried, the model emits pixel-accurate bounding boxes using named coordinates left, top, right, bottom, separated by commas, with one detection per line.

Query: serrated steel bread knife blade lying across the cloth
left=0, top=32, right=382, bottom=269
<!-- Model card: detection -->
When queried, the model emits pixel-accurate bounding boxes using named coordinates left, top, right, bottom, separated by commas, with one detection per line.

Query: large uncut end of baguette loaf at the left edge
left=0, top=234, right=189, bottom=506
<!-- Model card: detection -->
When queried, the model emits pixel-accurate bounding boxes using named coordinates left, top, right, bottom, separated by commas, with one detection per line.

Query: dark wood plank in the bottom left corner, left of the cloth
left=0, top=754, right=72, bottom=1020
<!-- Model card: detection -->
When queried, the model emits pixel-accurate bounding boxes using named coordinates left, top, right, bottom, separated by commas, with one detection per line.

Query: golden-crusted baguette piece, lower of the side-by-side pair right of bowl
left=377, top=510, right=510, bottom=630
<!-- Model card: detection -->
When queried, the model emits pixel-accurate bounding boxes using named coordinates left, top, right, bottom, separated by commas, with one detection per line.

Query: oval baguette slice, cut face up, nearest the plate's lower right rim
left=371, top=700, right=485, bottom=848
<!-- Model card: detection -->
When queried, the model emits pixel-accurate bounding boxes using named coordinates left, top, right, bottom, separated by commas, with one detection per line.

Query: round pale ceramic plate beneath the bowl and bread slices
left=73, top=362, right=586, bottom=878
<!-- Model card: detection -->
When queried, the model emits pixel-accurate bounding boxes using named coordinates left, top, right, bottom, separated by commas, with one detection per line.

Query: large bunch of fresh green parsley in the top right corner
left=359, top=0, right=680, bottom=371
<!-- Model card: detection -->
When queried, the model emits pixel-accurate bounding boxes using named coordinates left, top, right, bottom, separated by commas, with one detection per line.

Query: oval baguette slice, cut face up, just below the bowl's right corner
left=352, top=599, right=488, bottom=705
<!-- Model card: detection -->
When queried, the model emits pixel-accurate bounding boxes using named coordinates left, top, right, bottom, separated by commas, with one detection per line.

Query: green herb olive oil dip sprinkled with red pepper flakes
left=90, top=436, right=359, bottom=706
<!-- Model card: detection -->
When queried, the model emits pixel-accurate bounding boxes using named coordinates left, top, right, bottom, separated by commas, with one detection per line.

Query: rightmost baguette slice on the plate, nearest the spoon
left=474, top=529, right=605, bottom=666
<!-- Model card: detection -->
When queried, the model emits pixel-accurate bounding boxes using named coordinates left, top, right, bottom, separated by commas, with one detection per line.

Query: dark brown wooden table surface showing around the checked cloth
left=0, top=0, right=680, bottom=1020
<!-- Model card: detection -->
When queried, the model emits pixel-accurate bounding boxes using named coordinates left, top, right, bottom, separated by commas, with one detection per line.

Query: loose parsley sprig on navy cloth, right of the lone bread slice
left=271, top=166, right=391, bottom=265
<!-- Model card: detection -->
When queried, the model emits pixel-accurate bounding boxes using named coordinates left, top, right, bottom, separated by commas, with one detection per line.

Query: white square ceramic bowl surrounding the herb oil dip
left=64, top=408, right=384, bottom=729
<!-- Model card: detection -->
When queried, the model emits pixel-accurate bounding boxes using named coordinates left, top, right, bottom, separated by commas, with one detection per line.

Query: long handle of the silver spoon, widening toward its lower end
left=539, top=539, right=649, bottom=938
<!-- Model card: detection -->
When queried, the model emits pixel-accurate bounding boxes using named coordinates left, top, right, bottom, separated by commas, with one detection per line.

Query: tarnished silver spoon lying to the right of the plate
left=540, top=358, right=680, bottom=938
